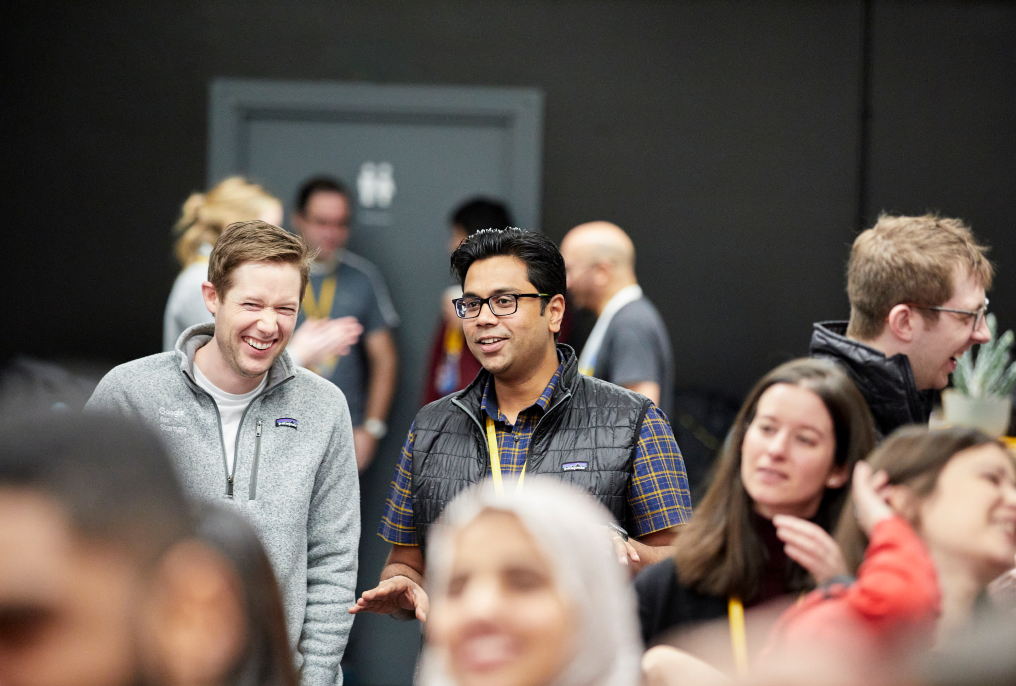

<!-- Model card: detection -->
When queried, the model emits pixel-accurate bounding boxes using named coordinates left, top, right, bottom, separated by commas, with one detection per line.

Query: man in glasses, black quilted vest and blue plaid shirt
left=350, top=229, right=691, bottom=620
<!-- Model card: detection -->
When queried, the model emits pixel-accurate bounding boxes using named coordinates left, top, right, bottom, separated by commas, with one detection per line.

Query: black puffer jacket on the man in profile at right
left=809, top=321, right=935, bottom=436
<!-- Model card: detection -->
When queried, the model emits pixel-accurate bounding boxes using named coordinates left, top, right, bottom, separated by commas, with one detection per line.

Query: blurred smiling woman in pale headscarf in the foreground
left=421, top=477, right=641, bottom=686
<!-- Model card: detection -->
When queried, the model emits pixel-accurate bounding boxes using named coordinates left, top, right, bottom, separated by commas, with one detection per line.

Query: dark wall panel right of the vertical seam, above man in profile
left=866, top=2, right=1016, bottom=329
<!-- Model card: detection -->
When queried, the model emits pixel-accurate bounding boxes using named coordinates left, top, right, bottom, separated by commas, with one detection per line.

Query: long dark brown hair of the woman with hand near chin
left=675, top=359, right=875, bottom=603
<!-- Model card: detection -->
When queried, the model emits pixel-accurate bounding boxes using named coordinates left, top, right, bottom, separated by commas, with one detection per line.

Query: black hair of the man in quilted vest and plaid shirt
left=451, top=228, right=567, bottom=314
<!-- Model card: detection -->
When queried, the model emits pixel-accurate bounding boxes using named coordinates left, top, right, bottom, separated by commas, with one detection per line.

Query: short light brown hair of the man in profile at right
left=846, top=214, right=994, bottom=340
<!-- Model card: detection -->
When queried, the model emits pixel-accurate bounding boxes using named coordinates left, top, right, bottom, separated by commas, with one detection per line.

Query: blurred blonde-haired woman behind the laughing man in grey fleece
left=163, top=176, right=282, bottom=351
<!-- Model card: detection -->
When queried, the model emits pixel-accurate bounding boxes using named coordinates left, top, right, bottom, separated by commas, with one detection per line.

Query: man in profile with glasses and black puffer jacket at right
left=811, top=214, right=994, bottom=436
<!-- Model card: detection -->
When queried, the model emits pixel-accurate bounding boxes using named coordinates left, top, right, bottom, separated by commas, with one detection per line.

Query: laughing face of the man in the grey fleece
left=212, top=262, right=301, bottom=379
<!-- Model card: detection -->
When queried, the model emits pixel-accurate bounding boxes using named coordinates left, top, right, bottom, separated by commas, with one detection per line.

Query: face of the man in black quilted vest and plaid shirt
left=462, top=256, right=564, bottom=380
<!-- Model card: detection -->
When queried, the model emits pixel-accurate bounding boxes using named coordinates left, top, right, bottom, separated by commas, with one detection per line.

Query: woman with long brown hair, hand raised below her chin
left=635, top=359, right=875, bottom=660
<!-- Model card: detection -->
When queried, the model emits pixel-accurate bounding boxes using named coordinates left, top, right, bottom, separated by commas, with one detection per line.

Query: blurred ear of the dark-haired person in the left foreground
left=148, top=541, right=248, bottom=686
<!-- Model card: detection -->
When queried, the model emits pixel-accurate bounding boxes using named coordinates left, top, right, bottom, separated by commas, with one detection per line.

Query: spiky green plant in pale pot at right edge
left=942, top=314, right=1016, bottom=436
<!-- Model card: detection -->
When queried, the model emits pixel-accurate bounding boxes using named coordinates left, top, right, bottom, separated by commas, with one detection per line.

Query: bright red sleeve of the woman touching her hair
left=764, top=517, right=941, bottom=653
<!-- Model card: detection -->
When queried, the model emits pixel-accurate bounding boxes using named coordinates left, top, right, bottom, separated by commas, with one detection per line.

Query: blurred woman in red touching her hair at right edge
left=649, top=427, right=1016, bottom=686
